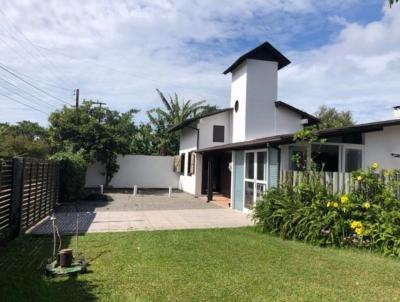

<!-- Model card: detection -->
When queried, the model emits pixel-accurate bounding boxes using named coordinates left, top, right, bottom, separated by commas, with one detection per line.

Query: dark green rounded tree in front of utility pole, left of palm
left=49, top=101, right=138, bottom=186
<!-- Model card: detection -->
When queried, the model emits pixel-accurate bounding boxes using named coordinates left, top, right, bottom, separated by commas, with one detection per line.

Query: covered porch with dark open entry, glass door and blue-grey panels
left=201, top=143, right=280, bottom=212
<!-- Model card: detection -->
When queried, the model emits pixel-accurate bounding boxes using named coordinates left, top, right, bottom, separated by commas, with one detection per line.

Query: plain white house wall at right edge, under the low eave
left=364, top=126, right=400, bottom=169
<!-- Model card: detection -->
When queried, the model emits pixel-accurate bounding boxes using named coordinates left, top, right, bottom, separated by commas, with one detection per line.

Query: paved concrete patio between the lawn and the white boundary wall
left=29, top=191, right=252, bottom=234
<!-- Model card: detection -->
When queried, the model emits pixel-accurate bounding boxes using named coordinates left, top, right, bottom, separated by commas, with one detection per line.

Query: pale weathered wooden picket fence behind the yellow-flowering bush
left=279, top=170, right=400, bottom=197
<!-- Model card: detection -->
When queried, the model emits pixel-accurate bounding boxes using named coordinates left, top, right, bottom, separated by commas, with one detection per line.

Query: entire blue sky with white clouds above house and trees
left=0, top=0, right=400, bottom=125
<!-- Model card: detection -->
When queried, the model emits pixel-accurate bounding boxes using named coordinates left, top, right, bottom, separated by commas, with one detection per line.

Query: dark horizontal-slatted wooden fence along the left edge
left=0, top=158, right=60, bottom=241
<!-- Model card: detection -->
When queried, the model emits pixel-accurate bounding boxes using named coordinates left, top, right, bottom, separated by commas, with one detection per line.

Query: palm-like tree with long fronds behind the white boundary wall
left=147, top=89, right=217, bottom=155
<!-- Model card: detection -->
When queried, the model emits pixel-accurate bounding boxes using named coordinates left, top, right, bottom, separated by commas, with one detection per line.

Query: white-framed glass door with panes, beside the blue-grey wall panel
left=244, top=150, right=268, bottom=210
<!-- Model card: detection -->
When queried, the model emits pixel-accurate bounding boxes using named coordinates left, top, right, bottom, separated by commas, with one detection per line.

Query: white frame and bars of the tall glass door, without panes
left=243, top=148, right=269, bottom=212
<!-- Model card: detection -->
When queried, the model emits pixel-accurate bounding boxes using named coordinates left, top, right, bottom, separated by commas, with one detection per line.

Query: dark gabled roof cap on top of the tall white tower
left=224, top=42, right=290, bottom=74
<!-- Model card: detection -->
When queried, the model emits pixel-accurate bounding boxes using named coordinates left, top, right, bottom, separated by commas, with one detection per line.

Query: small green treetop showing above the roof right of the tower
left=315, top=105, right=354, bottom=129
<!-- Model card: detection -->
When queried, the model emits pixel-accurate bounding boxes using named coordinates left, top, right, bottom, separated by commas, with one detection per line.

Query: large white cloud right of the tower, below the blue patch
left=280, top=3, right=400, bottom=122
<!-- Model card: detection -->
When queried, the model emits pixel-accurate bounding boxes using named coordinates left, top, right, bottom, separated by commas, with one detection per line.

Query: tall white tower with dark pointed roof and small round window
left=224, top=42, right=290, bottom=142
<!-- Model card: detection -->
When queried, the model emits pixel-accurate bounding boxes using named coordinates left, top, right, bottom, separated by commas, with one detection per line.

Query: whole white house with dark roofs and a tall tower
left=170, top=42, right=400, bottom=211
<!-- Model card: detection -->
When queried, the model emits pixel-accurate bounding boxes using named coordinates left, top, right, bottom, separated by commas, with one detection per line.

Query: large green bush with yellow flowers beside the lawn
left=253, top=164, right=400, bottom=256
